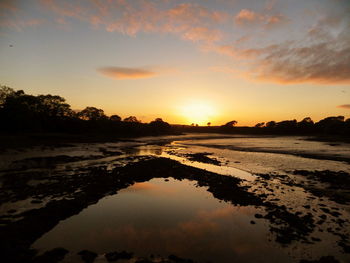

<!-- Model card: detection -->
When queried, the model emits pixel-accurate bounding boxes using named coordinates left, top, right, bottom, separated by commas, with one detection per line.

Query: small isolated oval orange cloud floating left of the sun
left=97, top=67, right=157, bottom=79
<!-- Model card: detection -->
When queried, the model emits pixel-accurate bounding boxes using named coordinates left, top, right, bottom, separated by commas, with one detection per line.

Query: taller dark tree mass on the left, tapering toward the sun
left=0, top=86, right=172, bottom=136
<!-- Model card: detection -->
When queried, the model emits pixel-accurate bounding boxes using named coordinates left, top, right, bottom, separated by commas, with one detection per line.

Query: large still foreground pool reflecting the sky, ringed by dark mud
left=33, top=179, right=290, bottom=262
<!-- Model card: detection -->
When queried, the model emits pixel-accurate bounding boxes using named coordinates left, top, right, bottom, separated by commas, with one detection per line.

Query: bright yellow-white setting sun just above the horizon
left=181, top=102, right=215, bottom=125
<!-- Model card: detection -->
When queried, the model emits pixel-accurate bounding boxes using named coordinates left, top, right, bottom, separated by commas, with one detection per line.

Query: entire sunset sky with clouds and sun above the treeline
left=0, top=0, right=350, bottom=125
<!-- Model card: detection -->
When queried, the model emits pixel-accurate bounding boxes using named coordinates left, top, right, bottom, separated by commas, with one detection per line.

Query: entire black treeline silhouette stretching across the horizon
left=0, top=86, right=350, bottom=137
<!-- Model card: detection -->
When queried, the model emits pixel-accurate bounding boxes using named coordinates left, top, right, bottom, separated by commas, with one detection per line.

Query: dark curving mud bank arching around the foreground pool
left=0, top=156, right=350, bottom=262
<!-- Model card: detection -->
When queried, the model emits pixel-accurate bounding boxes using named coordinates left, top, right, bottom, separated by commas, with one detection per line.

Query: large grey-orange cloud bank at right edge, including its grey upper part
left=211, top=9, right=350, bottom=84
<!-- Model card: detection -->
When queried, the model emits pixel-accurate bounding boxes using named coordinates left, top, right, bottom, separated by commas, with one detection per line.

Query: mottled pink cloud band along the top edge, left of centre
left=40, top=0, right=228, bottom=43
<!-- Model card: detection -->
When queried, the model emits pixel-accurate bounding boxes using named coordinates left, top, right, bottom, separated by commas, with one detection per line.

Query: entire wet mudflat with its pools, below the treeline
left=0, top=135, right=350, bottom=263
